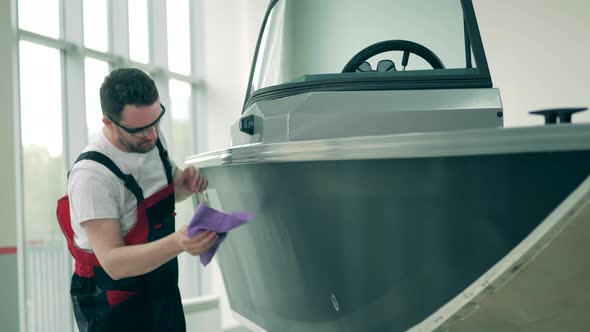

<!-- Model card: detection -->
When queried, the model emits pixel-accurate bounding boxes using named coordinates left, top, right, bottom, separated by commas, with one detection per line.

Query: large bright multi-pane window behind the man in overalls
left=17, top=0, right=200, bottom=332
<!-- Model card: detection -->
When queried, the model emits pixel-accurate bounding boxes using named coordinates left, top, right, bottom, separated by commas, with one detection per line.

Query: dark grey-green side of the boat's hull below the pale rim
left=197, top=150, right=590, bottom=332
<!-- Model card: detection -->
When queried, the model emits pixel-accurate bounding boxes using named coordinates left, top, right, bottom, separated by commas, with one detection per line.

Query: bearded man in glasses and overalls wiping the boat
left=58, top=68, right=218, bottom=331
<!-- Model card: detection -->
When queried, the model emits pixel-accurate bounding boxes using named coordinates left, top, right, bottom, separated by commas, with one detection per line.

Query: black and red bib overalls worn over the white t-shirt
left=57, top=139, right=186, bottom=332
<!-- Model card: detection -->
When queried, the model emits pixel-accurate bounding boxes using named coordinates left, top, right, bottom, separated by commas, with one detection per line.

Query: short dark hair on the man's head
left=100, top=68, right=159, bottom=121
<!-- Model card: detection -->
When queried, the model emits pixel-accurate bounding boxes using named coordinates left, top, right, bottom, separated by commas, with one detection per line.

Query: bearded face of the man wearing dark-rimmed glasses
left=113, top=100, right=164, bottom=153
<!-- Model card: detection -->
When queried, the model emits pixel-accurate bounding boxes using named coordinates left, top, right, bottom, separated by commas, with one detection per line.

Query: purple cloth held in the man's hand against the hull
left=187, top=204, right=252, bottom=266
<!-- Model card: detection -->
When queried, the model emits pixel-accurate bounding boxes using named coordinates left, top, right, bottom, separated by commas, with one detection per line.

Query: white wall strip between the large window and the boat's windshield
left=200, top=0, right=268, bottom=151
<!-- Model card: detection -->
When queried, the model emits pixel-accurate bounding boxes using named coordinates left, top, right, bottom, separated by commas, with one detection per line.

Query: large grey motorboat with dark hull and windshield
left=186, top=0, right=590, bottom=332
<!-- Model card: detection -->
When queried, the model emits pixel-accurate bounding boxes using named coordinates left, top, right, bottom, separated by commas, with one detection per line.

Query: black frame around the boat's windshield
left=242, top=0, right=493, bottom=114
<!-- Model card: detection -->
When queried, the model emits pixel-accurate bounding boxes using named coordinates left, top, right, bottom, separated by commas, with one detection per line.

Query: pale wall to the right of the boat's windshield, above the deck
left=473, top=0, right=590, bottom=126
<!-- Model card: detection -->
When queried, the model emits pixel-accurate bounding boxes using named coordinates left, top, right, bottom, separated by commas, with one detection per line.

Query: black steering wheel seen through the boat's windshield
left=342, top=39, right=445, bottom=73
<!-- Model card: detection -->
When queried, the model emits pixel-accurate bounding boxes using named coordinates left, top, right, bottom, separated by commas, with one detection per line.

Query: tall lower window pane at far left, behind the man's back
left=19, top=41, right=70, bottom=331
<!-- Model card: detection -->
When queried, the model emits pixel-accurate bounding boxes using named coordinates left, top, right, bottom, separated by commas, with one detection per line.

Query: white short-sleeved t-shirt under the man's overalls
left=68, top=130, right=176, bottom=250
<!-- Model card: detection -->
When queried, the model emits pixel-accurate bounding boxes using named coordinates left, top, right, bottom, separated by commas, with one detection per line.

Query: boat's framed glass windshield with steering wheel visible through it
left=246, top=0, right=491, bottom=110
